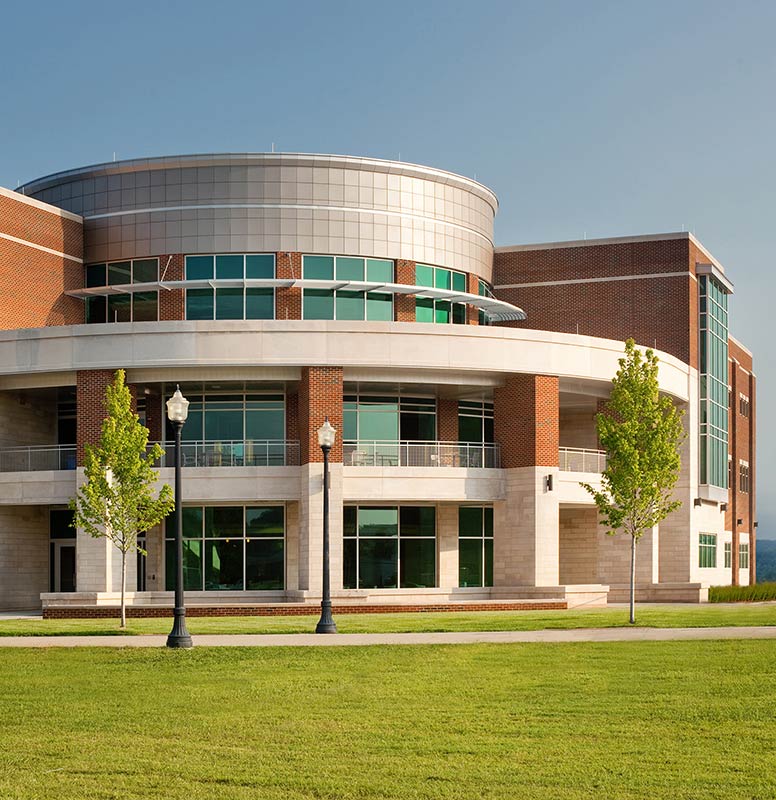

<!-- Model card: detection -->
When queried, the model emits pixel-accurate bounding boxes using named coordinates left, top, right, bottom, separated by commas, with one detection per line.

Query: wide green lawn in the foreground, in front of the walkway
left=0, top=641, right=776, bottom=800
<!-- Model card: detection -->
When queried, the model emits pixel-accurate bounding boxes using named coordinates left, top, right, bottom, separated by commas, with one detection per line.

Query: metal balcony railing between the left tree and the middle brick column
left=151, top=439, right=299, bottom=467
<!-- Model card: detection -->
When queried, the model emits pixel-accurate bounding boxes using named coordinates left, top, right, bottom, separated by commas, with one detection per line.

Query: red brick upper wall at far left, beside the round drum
left=0, top=189, right=84, bottom=330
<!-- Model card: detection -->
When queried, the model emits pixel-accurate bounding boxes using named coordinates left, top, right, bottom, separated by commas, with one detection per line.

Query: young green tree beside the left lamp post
left=70, top=369, right=174, bottom=628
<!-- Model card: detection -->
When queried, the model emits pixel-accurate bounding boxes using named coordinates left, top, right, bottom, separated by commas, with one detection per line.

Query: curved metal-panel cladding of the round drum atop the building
left=20, top=153, right=498, bottom=280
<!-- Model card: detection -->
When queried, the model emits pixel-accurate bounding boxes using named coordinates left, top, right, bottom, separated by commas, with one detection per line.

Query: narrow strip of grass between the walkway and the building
left=0, top=604, right=776, bottom=636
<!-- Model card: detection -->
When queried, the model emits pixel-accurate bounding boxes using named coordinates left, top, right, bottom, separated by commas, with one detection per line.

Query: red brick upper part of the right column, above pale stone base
left=493, top=374, right=560, bottom=469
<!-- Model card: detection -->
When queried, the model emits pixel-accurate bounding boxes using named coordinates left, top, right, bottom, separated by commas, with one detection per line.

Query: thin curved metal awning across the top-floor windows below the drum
left=65, top=278, right=526, bottom=322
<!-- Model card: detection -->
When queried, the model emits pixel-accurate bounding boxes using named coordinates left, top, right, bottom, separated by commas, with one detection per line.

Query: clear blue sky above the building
left=0, top=0, right=776, bottom=538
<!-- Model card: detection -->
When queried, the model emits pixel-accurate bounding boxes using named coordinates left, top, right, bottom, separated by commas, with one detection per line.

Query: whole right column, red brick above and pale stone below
left=493, top=375, right=560, bottom=587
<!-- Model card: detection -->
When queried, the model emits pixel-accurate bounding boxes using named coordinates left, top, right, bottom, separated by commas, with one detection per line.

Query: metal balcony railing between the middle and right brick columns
left=343, top=439, right=501, bottom=469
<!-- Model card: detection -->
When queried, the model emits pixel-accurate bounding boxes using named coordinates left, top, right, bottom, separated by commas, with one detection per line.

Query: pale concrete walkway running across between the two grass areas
left=0, top=626, right=776, bottom=647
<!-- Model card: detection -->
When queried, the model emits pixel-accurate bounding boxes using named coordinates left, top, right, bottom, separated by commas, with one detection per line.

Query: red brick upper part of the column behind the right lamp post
left=299, top=367, right=343, bottom=464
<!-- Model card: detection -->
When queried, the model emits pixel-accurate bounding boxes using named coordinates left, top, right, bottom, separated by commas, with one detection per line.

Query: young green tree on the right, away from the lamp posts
left=582, top=339, right=684, bottom=624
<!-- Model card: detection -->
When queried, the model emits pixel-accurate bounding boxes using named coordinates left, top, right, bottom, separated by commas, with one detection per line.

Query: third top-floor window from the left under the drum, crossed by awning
left=302, top=256, right=393, bottom=322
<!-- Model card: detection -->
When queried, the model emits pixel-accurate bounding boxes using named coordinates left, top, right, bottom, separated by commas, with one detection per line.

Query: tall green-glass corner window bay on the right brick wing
left=699, top=275, right=729, bottom=489
